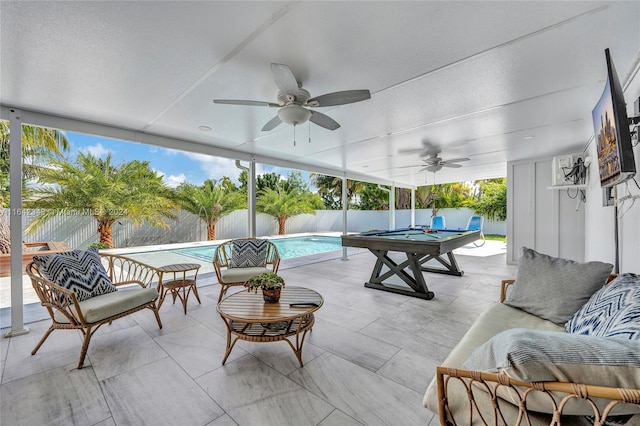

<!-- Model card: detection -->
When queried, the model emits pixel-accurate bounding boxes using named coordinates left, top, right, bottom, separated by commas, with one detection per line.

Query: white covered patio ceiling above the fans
left=0, top=1, right=640, bottom=187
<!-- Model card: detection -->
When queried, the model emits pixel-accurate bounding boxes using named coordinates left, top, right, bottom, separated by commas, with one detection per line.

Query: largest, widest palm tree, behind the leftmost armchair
left=25, top=153, right=178, bottom=248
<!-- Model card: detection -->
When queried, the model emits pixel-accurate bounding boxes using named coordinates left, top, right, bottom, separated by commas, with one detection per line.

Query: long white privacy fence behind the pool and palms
left=5, top=208, right=507, bottom=248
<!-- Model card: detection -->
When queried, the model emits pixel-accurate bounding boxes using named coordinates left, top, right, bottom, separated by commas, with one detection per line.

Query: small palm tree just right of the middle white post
left=256, top=187, right=323, bottom=235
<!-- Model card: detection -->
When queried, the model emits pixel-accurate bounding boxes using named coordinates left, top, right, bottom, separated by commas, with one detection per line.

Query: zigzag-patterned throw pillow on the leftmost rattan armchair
left=33, top=249, right=117, bottom=301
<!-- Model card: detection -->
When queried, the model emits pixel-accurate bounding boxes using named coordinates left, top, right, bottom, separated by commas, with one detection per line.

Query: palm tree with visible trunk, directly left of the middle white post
left=176, top=178, right=247, bottom=241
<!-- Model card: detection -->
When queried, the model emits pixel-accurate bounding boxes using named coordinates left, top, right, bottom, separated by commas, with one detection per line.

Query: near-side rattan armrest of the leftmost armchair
left=26, top=262, right=85, bottom=325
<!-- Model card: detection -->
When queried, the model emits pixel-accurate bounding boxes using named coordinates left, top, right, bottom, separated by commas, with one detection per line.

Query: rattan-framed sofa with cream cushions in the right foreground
left=423, top=249, right=640, bottom=426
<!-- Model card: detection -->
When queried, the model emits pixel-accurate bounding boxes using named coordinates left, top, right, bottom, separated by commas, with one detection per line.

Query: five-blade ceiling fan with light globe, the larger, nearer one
left=213, top=64, right=371, bottom=132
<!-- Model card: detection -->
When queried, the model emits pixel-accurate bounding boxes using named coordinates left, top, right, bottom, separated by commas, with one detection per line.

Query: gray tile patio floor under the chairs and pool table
left=0, top=241, right=516, bottom=426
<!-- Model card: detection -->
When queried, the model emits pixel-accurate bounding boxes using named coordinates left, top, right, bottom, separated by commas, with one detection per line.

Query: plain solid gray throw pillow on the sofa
left=505, top=247, right=613, bottom=326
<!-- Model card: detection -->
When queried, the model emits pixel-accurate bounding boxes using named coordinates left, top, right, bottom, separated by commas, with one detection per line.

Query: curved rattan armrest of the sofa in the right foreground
left=436, top=367, right=640, bottom=425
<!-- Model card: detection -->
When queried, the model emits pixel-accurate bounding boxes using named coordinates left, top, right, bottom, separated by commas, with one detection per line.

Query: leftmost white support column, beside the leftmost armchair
left=5, top=108, right=29, bottom=337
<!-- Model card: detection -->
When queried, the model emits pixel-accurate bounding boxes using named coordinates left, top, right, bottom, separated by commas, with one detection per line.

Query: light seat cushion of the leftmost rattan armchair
left=55, top=288, right=158, bottom=323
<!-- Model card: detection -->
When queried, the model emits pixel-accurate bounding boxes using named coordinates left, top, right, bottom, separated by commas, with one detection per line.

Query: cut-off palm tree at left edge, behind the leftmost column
left=0, top=120, right=69, bottom=254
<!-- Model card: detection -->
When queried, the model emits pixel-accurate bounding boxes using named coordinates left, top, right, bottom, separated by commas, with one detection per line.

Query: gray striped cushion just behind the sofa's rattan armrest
left=463, top=328, right=640, bottom=415
